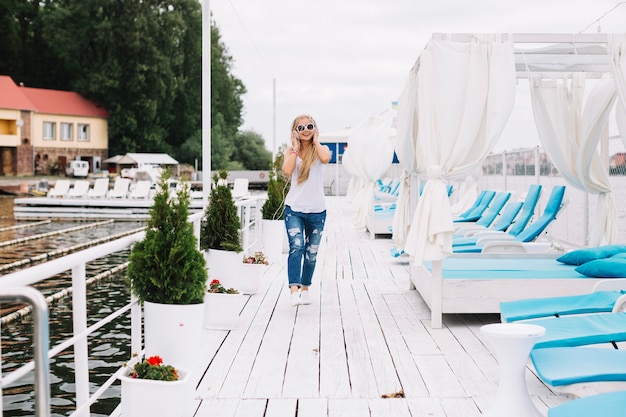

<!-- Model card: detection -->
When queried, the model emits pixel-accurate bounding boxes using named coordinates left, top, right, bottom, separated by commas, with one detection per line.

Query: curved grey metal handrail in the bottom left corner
left=0, top=287, right=50, bottom=417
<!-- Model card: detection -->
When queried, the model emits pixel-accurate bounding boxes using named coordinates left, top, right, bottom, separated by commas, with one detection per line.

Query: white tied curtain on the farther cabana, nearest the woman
left=342, top=110, right=395, bottom=230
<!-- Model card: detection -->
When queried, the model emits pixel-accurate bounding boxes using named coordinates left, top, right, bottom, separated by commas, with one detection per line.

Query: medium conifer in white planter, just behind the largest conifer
left=200, top=170, right=243, bottom=288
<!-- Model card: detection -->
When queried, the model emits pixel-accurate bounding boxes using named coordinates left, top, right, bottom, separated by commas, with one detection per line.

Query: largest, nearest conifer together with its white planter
left=127, top=167, right=207, bottom=372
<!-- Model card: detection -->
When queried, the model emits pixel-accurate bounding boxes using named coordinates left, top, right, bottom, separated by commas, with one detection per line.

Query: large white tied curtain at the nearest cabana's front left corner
left=405, top=36, right=516, bottom=265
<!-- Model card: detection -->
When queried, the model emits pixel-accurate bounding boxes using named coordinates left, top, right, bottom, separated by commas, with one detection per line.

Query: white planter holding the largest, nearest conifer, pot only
left=143, top=301, right=204, bottom=373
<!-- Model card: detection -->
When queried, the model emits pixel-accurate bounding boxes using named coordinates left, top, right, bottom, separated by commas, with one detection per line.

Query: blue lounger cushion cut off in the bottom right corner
left=548, top=391, right=626, bottom=417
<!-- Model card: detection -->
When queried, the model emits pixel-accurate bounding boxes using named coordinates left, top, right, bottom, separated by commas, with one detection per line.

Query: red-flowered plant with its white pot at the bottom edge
left=119, top=355, right=193, bottom=417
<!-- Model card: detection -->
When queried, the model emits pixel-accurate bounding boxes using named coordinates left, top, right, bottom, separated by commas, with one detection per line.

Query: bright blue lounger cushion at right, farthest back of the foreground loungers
left=500, top=291, right=626, bottom=323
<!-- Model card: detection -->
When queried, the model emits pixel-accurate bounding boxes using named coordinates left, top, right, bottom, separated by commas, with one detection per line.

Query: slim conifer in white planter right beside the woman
left=261, top=146, right=290, bottom=262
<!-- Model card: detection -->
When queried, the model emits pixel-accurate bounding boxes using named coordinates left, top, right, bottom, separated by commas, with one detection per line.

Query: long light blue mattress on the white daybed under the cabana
left=424, top=257, right=588, bottom=279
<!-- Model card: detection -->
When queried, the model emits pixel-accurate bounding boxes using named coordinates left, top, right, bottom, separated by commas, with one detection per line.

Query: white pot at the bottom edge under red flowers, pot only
left=119, top=363, right=193, bottom=417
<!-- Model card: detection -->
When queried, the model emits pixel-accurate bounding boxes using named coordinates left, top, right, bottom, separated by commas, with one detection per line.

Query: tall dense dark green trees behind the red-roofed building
left=0, top=0, right=251, bottom=168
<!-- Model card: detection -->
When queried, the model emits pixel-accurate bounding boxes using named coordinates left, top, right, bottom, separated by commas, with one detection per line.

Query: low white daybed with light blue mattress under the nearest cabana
left=410, top=254, right=597, bottom=327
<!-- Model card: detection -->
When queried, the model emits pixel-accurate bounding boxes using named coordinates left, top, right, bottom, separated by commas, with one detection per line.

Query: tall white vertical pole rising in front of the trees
left=202, top=0, right=211, bottom=204
